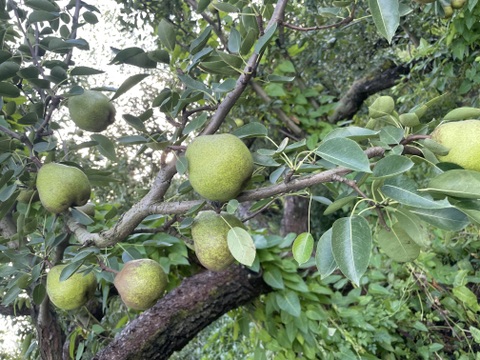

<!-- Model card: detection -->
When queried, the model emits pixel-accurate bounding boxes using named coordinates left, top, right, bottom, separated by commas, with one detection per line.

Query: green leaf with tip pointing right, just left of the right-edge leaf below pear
left=380, top=177, right=451, bottom=209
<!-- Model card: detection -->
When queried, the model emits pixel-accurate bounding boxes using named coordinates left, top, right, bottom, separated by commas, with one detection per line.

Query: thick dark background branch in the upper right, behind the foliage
left=329, top=64, right=410, bottom=123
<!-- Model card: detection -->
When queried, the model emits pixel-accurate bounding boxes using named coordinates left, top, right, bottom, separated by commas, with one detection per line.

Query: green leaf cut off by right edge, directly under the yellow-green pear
left=422, top=169, right=480, bottom=199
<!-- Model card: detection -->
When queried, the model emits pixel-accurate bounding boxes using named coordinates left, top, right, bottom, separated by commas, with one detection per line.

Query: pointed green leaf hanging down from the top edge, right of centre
left=368, top=0, right=400, bottom=43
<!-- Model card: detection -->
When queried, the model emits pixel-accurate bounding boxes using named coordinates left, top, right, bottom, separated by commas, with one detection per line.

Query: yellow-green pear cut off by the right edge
left=431, top=120, right=480, bottom=171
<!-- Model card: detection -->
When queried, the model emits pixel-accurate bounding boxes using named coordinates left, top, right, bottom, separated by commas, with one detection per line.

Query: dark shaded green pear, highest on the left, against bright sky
left=68, top=90, right=116, bottom=132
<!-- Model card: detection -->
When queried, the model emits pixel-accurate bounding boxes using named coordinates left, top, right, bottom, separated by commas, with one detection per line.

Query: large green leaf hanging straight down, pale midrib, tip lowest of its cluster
left=332, top=215, right=372, bottom=285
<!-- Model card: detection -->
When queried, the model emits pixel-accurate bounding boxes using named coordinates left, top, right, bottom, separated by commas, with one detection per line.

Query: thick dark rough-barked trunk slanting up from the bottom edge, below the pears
left=93, top=266, right=269, bottom=360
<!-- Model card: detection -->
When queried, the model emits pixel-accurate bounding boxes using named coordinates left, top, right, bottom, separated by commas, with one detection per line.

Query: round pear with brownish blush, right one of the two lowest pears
left=113, top=259, right=168, bottom=310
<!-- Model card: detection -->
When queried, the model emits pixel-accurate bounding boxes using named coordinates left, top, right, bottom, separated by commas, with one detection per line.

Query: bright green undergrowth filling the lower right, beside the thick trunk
left=171, top=227, right=480, bottom=360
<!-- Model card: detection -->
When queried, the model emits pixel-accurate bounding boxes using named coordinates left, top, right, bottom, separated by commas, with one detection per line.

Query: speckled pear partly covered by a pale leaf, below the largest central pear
left=192, top=210, right=245, bottom=271
